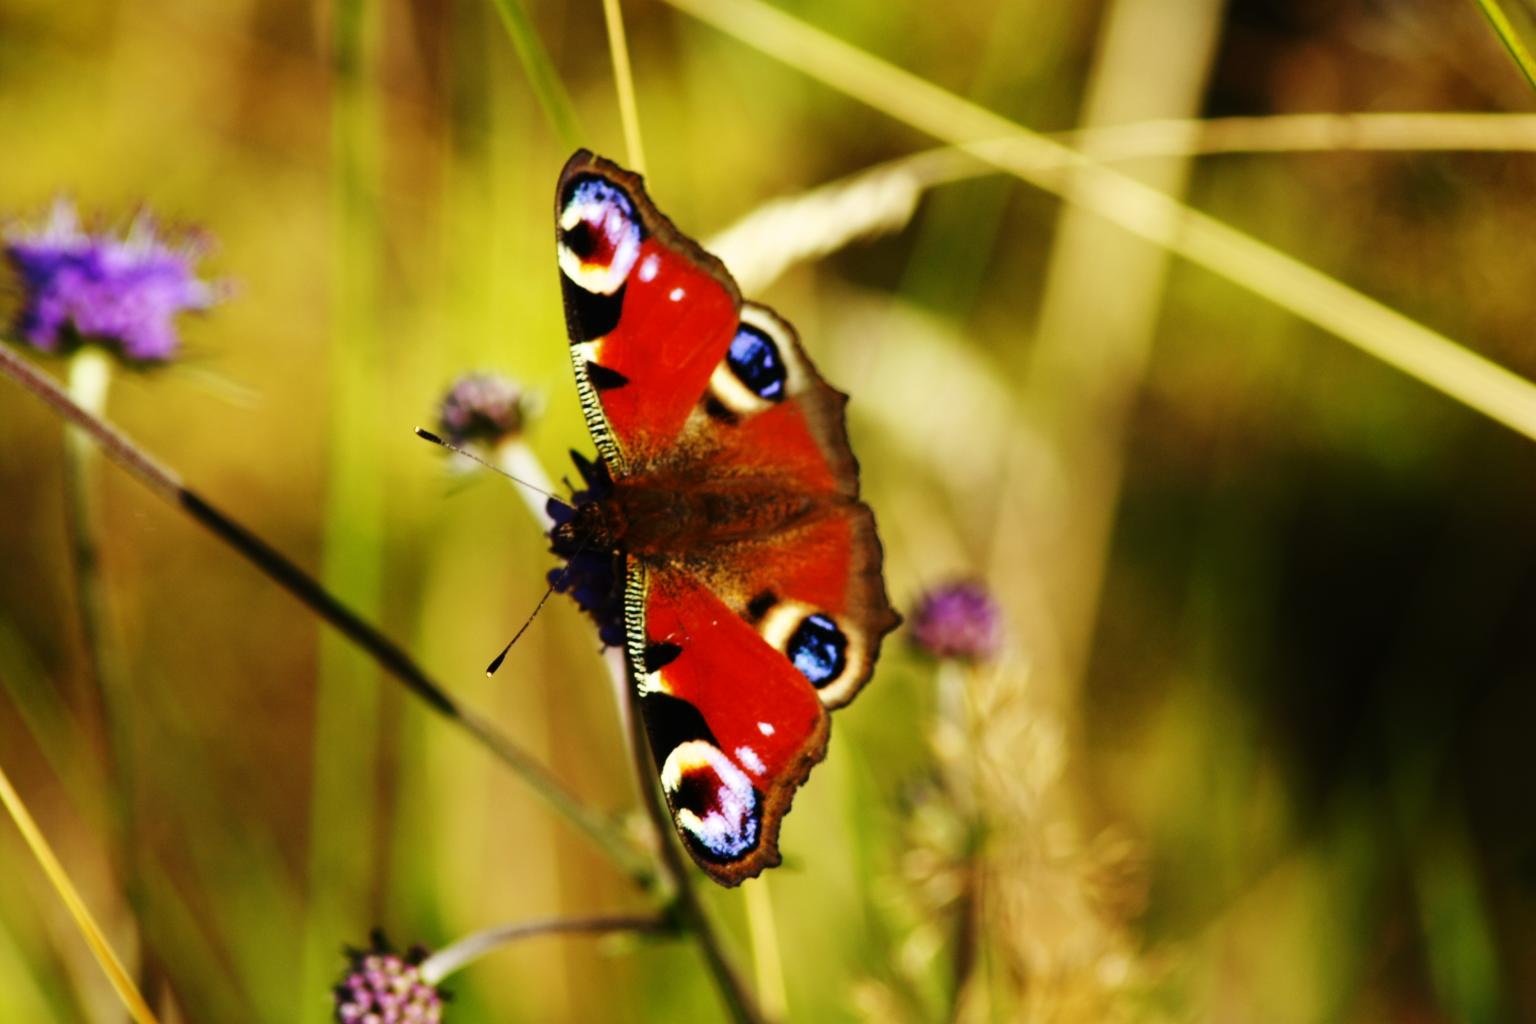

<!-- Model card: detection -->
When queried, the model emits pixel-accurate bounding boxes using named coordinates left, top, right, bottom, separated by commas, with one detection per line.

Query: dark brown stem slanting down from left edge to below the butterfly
left=0, top=344, right=653, bottom=884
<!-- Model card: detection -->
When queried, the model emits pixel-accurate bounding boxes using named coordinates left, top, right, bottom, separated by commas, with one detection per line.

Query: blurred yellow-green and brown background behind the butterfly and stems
left=0, top=0, right=1536, bottom=1022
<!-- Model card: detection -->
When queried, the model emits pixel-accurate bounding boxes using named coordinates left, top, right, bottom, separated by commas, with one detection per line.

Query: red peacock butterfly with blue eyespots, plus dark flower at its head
left=550, top=150, right=900, bottom=886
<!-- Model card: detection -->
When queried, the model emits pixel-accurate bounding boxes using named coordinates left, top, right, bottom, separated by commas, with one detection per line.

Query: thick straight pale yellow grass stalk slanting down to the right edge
left=667, top=0, right=1536, bottom=439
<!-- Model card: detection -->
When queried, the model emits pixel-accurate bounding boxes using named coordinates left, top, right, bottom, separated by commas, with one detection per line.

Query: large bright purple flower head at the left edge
left=5, top=200, right=223, bottom=364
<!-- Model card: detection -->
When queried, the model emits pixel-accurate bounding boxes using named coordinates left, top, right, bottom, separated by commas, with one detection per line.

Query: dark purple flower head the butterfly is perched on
left=545, top=451, right=624, bottom=646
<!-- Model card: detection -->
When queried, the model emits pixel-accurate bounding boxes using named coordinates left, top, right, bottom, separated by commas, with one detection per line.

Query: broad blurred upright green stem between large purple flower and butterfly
left=301, top=0, right=389, bottom=998
